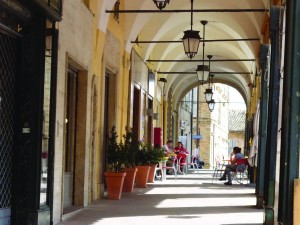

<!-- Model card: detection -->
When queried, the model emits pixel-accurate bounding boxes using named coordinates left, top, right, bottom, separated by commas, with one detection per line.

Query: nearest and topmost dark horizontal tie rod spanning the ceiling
left=105, top=9, right=269, bottom=13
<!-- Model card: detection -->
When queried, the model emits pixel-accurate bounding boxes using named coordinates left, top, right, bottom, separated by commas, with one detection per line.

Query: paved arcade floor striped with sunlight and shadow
left=60, top=170, right=263, bottom=225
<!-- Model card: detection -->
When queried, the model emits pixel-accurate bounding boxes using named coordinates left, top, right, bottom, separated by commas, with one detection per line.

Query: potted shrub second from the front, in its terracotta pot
left=120, top=128, right=140, bottom=192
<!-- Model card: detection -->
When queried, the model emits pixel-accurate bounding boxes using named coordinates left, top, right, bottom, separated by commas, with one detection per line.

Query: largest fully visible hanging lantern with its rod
left=182, top=0, right=200, bottom=59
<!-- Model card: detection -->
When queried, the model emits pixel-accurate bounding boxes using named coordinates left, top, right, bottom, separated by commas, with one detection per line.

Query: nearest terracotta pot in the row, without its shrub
left=105, top=172, right=126, bottom=200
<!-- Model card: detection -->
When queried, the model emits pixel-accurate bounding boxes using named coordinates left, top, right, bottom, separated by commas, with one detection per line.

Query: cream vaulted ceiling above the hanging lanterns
left=100, top=0, right=269, bottom=104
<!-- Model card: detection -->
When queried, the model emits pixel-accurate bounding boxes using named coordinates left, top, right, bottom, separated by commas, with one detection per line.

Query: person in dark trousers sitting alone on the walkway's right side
left=219, top=147, right=246, bottom=185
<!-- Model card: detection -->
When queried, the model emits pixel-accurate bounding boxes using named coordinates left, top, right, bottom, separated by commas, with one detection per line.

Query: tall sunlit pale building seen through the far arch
left=185, top=84, right=229, bottom=168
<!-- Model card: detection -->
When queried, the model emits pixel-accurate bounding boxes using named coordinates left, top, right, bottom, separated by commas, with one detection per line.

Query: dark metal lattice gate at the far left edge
left=0, top=30, right=16, bottom=225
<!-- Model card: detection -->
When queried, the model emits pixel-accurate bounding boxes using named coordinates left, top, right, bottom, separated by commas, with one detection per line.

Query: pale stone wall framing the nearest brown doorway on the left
left=53, top=0, right=93, bottom=224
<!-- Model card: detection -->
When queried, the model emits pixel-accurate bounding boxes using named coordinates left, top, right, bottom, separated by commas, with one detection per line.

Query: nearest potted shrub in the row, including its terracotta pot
left=105, top=127, right=126, bottom=200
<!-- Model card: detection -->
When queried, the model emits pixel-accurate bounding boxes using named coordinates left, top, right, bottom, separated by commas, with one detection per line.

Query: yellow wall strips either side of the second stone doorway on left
left=89, top=0, right=130, bottom=199
